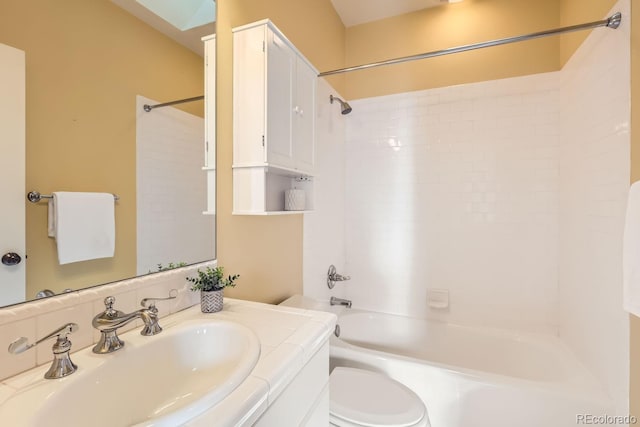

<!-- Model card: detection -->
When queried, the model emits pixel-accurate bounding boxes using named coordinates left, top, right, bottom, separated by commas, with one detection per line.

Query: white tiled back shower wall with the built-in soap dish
left=345, top=73, right=560, bottom=331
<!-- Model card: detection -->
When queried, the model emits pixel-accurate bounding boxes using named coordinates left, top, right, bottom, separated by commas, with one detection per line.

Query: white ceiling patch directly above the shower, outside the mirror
left=331, top=0, right=453, bottom=27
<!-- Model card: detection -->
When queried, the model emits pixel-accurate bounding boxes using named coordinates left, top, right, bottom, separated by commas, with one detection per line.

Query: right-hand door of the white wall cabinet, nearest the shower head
left=293, top=58, right=318, bottom=175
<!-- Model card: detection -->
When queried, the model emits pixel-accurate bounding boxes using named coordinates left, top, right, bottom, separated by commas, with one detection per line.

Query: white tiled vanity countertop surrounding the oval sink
left=0, top=298, right=336, bottom=427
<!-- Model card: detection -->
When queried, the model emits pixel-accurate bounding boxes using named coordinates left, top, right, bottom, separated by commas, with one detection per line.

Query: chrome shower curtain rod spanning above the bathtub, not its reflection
left=318, top=12, right=622, bottom=77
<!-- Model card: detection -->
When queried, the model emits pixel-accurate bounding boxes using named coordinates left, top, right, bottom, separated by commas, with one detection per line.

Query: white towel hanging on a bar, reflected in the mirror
left=48, top=191, right=116, bottom=264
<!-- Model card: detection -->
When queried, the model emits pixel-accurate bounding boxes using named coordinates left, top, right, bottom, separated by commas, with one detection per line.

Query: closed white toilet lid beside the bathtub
left=329, top=367, right=426, bottom=427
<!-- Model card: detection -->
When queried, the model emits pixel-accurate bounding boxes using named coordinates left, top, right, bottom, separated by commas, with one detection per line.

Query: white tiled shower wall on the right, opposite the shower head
left=559, top=0, right=630, bottom=414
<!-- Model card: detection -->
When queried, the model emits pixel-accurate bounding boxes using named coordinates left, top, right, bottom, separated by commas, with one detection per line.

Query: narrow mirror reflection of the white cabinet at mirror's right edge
left=202, top=34, right=216, bottom=215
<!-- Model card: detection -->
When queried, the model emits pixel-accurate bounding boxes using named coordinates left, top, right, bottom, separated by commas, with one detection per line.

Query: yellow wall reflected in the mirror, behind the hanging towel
left=0, top=0, right=204, bottom=298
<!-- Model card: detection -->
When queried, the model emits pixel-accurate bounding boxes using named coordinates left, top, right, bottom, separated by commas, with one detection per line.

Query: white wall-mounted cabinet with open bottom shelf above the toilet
left=233, top=20, right=318, bottom=214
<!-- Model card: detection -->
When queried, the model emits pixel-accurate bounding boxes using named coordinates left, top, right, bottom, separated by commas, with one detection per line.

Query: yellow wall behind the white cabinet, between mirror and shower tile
left=216, top=0, right=344, bottom=302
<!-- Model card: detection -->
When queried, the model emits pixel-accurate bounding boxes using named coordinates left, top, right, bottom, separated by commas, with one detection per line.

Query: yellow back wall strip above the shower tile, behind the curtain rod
left=345, top=0, right=560, bottom=99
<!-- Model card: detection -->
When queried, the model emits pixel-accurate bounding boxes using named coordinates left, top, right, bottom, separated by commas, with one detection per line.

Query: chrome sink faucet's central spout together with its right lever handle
left=91, top=289, right=177, bottom=354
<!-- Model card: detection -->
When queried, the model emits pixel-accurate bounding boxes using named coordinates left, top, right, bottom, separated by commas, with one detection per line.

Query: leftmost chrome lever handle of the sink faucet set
left=9, top=323, right=78, bottom=380
